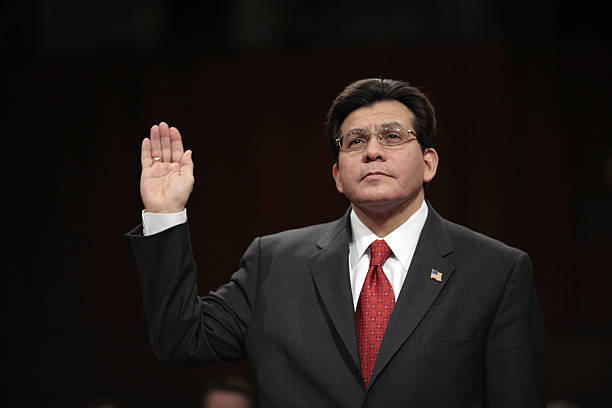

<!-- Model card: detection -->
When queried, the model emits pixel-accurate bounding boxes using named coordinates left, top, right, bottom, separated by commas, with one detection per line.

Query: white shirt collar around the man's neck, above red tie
left=350, top=200, right=428, bottom=270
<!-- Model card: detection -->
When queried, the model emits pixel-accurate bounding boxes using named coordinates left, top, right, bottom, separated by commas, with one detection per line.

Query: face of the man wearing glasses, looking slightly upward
left=332, top=100, right=438, bottom=211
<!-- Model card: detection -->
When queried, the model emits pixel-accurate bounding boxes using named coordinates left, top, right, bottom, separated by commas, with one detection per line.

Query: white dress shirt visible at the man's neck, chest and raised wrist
left=142, top=201, right=427, bottom=310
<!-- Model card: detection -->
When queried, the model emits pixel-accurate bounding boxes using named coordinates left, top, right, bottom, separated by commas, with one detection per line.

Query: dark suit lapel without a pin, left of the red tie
left=309, top=209, right=361, bottom=372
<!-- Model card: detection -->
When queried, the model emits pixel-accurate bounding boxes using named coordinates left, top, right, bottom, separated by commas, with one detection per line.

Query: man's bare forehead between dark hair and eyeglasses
left=340, top=100, right=414, bottom=133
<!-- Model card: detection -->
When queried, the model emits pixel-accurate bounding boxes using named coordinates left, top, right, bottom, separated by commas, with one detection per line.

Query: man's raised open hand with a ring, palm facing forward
left=140, top=122, right=194, bottom=213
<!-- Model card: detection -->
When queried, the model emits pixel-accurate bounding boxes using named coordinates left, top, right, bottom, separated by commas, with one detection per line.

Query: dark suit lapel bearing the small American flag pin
left=370, top=203, right=454, bottom=386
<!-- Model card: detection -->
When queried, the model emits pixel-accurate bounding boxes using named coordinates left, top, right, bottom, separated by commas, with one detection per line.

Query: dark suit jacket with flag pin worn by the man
left=127, top=204, right=546, bottom=408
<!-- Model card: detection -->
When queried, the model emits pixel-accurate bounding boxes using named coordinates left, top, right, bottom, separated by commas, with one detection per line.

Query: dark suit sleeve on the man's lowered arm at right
left=485, top=252, right=546, bottom=408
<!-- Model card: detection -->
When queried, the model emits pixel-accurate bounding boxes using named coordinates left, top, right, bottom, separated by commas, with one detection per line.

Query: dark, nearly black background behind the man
left=0, top=0, right=612, bottom=407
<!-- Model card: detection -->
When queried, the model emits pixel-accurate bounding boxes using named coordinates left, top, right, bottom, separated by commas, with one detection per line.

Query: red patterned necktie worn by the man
left=355, top=239, right=395, bottom=387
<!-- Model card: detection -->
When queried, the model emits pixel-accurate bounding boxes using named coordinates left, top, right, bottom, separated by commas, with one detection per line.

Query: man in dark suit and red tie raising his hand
left=128, top=79, right=545, bottom=408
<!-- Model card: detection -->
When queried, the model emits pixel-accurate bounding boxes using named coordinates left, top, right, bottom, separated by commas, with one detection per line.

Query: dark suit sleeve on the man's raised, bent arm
left=126, top=224, right=259, bottom=362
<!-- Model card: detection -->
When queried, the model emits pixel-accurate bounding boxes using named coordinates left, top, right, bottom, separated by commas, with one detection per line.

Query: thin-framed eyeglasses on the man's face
left=336, top=125, right=417, bottom=153
